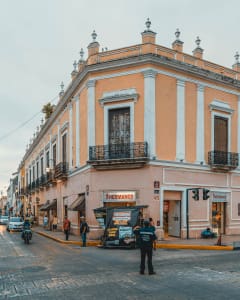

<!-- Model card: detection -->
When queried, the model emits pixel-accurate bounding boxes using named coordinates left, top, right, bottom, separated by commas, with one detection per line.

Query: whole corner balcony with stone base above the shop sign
left=88, top=142, right=148, bottom=170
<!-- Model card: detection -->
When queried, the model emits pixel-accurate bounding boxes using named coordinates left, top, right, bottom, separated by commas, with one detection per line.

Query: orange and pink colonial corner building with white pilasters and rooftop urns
left=18, top=20, right=240, bottom=239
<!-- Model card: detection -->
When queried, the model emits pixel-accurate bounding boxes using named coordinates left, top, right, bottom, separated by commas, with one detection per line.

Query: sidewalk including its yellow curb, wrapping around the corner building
left=32, top=226, right=240, bottom=251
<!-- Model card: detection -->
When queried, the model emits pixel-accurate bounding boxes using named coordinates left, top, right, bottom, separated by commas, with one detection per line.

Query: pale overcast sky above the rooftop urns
left=0, top=0, right=240, bottom=195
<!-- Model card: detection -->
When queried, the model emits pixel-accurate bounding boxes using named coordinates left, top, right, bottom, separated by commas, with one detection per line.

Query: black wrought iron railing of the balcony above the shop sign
left=89, top=142, right=148, bottom=163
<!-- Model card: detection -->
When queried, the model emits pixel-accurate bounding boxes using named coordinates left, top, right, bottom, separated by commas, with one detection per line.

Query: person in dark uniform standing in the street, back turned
left=134, top=220, right=157, bottom=275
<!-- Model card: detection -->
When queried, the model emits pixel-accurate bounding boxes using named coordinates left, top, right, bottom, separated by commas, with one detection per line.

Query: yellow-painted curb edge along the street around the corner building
left=34, top=231, right=234, bottom=251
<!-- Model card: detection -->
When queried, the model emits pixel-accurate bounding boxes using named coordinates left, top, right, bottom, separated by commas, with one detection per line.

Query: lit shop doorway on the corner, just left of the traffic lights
left=167, top=200, right=181, bottom=237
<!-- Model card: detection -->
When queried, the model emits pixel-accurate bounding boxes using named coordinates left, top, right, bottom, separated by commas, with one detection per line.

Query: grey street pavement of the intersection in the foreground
left=0, top=225, right=240, bottom=300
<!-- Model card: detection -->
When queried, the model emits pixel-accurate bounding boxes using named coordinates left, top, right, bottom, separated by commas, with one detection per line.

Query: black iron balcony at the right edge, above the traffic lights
left=208, top=151, right=238, bottom=172
